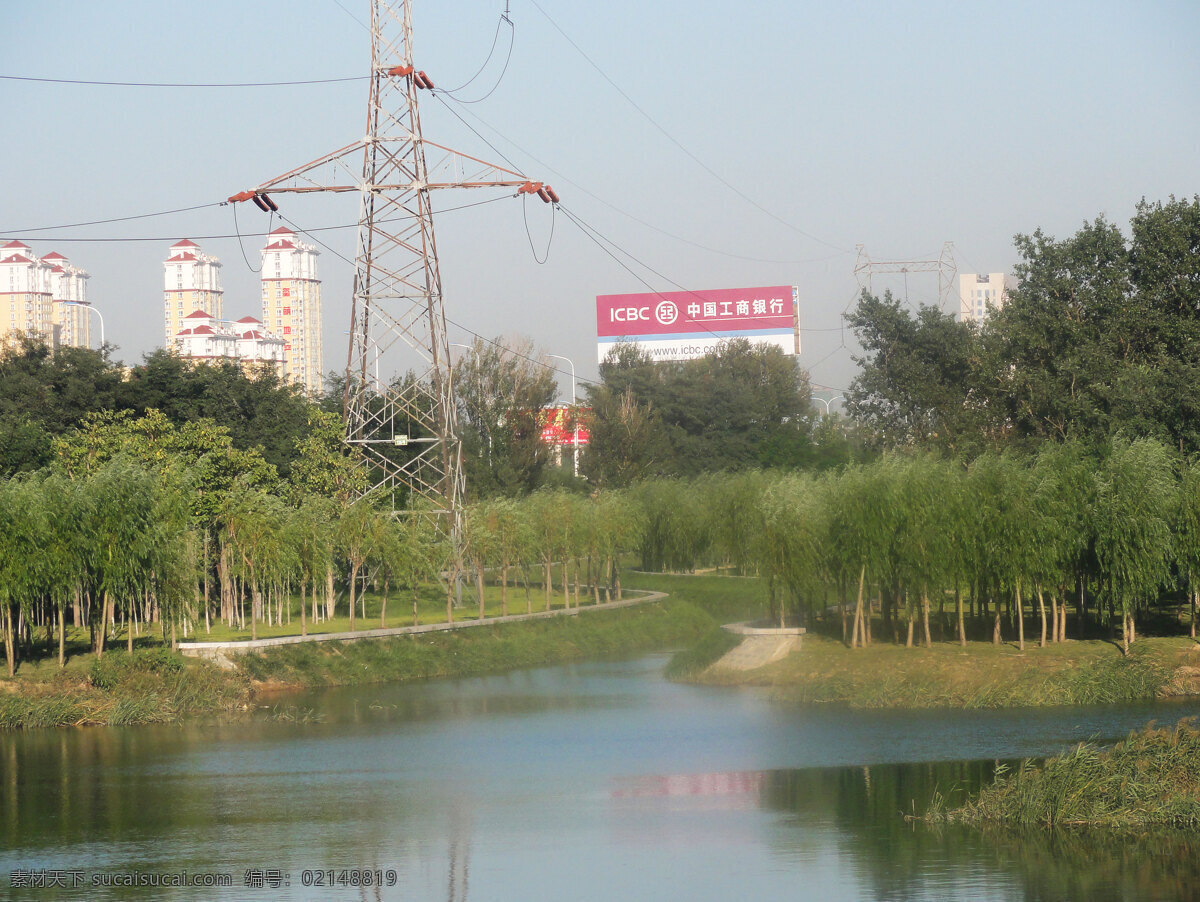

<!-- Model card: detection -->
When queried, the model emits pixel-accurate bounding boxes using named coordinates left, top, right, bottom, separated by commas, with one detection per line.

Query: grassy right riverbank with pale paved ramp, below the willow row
left=686, top=633, right=1200, bottom=709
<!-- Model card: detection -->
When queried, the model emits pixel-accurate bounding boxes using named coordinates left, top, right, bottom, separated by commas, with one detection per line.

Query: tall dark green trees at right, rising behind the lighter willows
left=847, top=197, right=1200, bottom=453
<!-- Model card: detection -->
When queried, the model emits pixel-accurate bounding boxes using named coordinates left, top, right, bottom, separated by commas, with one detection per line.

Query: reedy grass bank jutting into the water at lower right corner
left=926, top=722, right=1200, bottom=830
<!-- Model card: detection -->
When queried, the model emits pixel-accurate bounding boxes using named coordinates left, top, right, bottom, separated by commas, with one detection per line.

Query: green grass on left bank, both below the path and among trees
left=0, top=577, right=763, bottom=729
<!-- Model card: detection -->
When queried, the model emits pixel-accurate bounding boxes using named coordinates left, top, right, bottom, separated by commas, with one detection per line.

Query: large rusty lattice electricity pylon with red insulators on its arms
left=229, top=0, right=558, bottom=559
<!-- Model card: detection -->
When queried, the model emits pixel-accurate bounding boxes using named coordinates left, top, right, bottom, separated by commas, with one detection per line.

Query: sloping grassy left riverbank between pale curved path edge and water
left=0, top=593, right=725, bottom=729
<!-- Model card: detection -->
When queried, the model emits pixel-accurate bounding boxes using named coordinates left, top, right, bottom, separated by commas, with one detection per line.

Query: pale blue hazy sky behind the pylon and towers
left=0, top=0, right=1200, bottom=399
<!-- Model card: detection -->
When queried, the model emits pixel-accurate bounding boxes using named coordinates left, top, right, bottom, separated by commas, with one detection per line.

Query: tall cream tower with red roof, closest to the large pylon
left=262, top=227, right=323, bottom=395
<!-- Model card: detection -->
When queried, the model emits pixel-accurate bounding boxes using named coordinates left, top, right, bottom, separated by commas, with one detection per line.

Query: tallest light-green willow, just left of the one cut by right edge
left=1096, top=437, right=1175, bottom=654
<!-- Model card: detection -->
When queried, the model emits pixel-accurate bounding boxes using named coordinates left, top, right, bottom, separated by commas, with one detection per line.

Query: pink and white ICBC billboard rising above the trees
left=596, top=285, right=800, bottom=361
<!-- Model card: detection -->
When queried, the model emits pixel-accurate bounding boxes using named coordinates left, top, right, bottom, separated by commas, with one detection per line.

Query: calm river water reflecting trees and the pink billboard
left=0, top=656, right=1200, bottom=902
